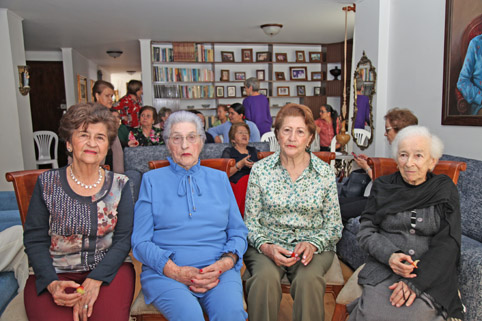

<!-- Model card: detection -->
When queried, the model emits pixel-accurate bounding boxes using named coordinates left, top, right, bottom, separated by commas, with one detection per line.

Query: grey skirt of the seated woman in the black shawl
left=347, top=276, right=445, bottom=321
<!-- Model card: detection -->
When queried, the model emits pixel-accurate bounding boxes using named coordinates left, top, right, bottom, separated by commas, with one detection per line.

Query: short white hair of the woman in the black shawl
left=392, top=125, right=444, bottom=162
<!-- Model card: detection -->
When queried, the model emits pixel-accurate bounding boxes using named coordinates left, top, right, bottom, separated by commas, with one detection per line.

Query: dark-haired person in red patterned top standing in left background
left=113, top=79, right=143, bottom=128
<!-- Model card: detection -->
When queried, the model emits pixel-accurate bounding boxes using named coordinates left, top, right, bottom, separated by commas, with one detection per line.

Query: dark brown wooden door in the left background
left=27, top=61, right=67, bottom=166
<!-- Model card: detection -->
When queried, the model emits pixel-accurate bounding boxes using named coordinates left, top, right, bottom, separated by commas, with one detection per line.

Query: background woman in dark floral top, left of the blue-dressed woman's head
left=128, top=106, right=164, bottom=147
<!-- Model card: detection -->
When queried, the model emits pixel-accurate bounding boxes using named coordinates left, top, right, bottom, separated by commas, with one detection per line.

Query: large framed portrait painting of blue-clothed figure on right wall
left=442, top=0, right=482, bottom=126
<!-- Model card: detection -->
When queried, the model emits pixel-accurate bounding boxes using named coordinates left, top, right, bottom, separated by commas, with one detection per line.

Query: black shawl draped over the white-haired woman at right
left=361, top=172, right=463, bottom=318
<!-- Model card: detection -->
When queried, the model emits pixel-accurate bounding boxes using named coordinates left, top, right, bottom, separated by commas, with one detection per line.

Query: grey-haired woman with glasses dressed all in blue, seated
left=132, top=111, right=248, bottom=321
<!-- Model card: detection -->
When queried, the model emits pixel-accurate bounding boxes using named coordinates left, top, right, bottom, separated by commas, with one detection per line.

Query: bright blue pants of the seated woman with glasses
left=152, top=270, right=248, bottom=321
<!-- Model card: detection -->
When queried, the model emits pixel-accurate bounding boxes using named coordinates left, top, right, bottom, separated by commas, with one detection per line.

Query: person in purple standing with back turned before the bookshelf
left=243, top=77, right=273, bottom=136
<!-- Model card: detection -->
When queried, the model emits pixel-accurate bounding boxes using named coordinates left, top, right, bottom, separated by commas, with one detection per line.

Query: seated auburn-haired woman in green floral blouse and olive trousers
left=244, top=104, right=342, bottom=321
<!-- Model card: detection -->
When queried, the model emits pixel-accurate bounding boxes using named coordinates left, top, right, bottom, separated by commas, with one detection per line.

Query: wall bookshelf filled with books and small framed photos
left=149, top=41, right=351, bottom=124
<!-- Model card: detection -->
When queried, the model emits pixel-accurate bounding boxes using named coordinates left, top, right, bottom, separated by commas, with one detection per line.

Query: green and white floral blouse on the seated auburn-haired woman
left=244, top=152, right=343, bottom=253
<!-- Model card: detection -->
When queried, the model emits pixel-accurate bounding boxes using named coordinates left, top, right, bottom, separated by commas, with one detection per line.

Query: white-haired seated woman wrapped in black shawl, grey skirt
left=348, top=126, right=463, bottom=321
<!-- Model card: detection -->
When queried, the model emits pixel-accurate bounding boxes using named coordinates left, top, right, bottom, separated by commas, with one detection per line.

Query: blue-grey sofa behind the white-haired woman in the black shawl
left=337, top=155, right=482, bottom=321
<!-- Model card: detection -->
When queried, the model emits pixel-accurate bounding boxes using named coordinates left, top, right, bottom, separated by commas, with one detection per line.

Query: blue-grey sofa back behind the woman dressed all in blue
left=124, top=142, right=269, bottom=200
